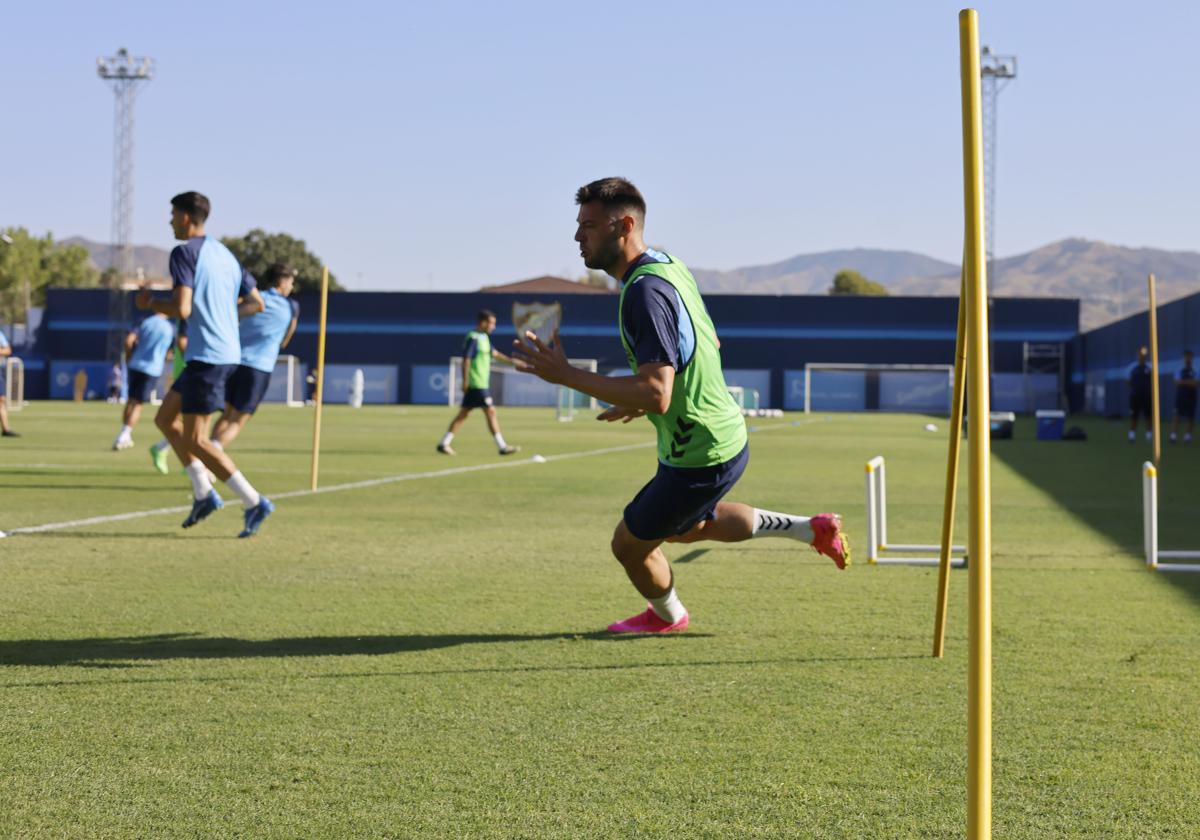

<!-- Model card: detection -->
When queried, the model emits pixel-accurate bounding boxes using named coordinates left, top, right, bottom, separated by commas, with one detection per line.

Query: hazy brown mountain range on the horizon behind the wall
left=62, top=236, right=1200, bottom=330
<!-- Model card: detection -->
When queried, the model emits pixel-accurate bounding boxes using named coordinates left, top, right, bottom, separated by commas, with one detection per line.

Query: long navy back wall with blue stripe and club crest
left=35, top=289, right=1084, bottom=408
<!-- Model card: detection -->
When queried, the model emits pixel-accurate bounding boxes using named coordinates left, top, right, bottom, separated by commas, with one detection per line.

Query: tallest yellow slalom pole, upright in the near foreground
left=959, top=8, right=991, bottom=840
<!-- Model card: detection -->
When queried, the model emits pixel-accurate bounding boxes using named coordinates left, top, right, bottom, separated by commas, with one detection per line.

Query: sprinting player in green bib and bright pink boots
left=514, top=178, right=850, bottom=632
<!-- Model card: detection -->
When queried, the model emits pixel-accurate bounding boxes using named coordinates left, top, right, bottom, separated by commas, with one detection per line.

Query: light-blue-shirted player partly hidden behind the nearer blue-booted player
left=212, top=263, right=300, bottom=449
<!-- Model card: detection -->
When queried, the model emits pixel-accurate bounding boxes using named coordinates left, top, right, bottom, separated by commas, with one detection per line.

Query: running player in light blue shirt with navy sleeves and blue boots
left=137, top=192, right=275, bottom=536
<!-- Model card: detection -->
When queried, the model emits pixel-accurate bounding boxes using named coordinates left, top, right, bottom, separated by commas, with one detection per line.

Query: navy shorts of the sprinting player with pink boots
left=625, top=444, right=750, bottom=541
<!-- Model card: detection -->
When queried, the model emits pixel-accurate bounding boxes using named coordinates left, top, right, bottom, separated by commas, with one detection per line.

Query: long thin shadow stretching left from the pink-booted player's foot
left=0, top=630, right=709, bottom=667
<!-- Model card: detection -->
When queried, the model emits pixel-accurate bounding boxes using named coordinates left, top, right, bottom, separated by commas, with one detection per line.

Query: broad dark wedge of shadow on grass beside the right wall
left=991, top=418, right=1200, bottom=601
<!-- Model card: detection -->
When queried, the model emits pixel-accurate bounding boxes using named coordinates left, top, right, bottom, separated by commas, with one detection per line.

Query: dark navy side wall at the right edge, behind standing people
left=1072, top=293, right=1200, bottom=418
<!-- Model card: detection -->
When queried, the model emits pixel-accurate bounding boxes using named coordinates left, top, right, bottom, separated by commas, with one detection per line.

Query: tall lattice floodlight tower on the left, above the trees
left=96, top=47, right=154, bottom=278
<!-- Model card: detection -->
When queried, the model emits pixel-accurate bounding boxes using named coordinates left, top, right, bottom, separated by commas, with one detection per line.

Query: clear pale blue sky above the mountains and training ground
left=0, top=0, right=1200, bottom=290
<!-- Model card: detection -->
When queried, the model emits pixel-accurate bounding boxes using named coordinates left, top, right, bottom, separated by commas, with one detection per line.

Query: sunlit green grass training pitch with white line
left=0, top=403, right=1200, bottom=840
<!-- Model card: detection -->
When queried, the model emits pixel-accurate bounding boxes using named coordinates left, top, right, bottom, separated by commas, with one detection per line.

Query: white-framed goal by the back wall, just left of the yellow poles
left=804, top=362, right=954, bottom=415
